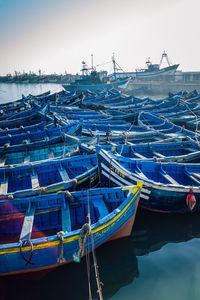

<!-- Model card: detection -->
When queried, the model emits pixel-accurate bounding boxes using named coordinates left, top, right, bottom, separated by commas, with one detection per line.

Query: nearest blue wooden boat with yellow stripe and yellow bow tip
left=0, top=182, right=142, bottom=277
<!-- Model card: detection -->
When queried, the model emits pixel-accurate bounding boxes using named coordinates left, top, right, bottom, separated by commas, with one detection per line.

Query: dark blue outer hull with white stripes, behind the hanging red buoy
left=97, top=149, right=200, bottom=213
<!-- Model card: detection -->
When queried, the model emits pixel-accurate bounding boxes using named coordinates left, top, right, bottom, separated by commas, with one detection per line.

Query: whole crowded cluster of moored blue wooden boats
left=0, top=88, right=200, bottom=276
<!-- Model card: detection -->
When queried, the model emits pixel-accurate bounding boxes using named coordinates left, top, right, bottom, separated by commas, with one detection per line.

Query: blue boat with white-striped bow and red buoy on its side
left=97, top=147, right=200, bottom=213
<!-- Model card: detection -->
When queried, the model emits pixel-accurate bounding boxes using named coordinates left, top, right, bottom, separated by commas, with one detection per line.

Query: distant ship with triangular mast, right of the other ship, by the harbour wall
left=111, top=51, right=179, bottom=79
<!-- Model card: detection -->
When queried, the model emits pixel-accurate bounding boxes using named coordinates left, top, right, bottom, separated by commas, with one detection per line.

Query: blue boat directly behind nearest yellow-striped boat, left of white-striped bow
left=0, top=154, right=99, bottom=198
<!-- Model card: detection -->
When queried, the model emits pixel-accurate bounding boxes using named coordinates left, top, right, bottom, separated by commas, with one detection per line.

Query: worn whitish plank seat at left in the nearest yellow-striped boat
left=19, top=206, right=35, bottom=241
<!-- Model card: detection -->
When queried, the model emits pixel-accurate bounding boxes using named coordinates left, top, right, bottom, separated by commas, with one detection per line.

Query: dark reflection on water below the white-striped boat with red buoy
left=131, top=209, right=200, bottom=256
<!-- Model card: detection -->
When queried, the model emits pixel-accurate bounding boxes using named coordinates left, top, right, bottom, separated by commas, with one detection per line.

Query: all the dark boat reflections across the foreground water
left=1, top=210, right=200, bottom=300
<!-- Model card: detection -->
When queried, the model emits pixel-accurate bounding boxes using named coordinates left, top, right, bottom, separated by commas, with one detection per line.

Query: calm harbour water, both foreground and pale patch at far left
left=0, top=84, right=200, bottom=300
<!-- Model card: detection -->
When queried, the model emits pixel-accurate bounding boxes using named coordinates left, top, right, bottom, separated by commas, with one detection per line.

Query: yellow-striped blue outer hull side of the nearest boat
left=0, top=183, right=142, bottom=277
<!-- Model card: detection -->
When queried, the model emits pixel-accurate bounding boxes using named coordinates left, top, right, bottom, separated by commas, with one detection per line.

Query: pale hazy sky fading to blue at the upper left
left=0, top=0, right=200, bottom=75
